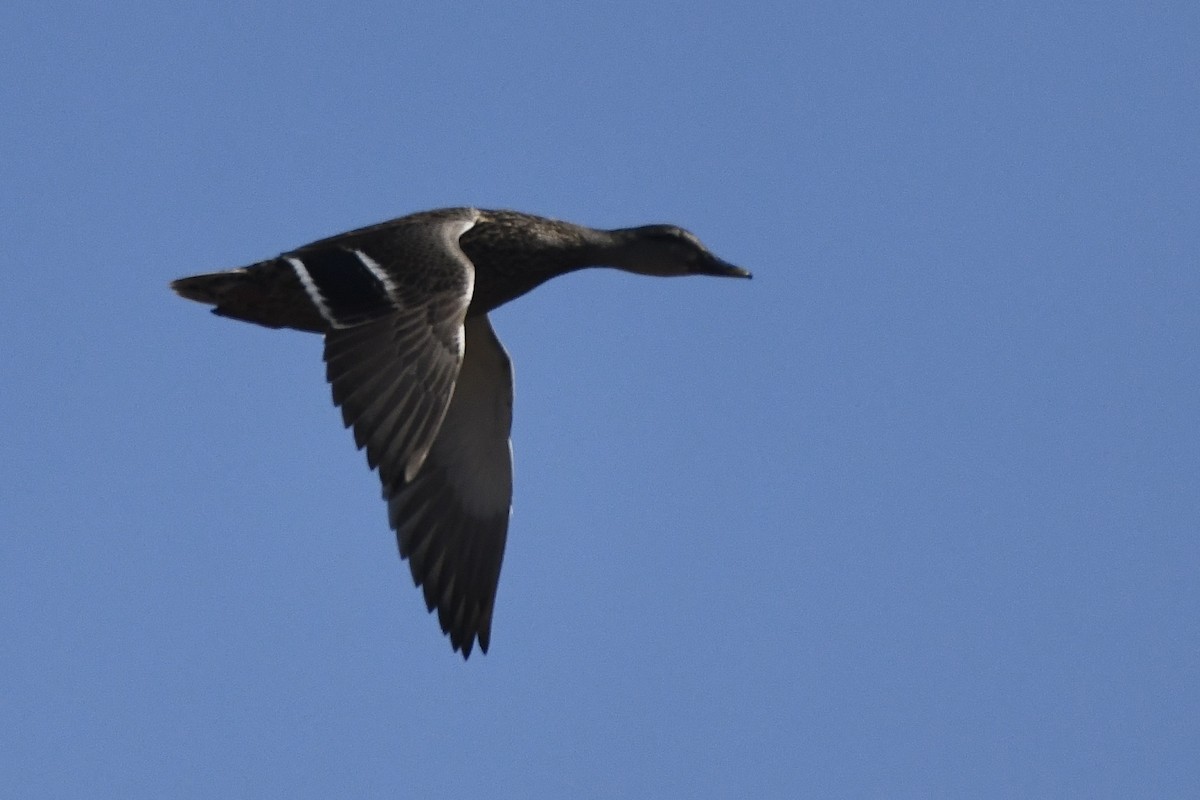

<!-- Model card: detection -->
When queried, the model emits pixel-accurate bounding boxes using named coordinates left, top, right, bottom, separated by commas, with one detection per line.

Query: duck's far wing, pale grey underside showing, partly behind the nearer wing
left=385, top=315, right=512, bottom=658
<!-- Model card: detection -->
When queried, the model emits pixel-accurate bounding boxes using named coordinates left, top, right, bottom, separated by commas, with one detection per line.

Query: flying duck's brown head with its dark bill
left=610, top=225, right=751, bottom=278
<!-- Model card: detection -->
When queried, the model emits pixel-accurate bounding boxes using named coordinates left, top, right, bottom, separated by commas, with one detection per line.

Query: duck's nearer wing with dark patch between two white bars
left=321, top=209, right=474, bottom=497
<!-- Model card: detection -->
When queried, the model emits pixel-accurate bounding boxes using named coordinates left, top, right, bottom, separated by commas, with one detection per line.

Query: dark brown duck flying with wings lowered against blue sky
left=170, top=207, right=751, bottom=660
